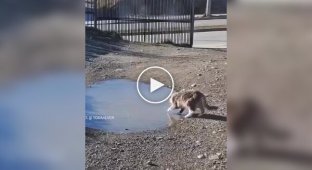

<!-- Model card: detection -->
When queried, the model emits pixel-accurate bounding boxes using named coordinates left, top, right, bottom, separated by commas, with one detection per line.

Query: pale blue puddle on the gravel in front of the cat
left=86, top=79, right=170, bottom=133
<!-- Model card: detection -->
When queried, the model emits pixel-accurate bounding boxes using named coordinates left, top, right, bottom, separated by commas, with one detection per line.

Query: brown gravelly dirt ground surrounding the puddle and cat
left=85, top=29, right=227, bottom=169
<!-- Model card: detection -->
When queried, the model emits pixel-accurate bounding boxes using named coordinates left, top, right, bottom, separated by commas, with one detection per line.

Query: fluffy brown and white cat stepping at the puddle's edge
left=167, top=91, right=211, bottom=118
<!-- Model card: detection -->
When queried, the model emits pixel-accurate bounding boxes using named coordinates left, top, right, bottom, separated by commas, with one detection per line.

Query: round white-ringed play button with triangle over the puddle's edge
left=137, top=66, right=174, bottom=104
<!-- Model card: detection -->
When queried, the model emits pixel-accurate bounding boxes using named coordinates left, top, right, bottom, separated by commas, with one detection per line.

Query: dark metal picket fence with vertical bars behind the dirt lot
left=85, top=0, right=194, bottom=46
